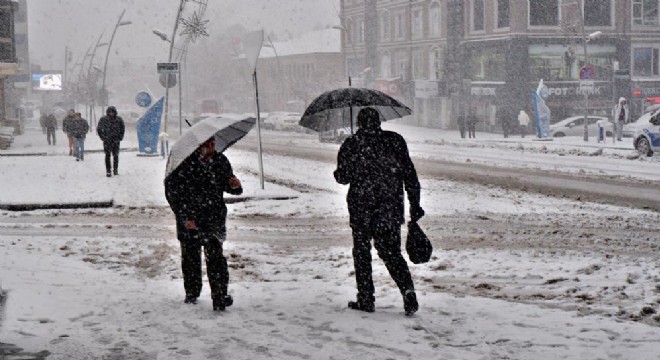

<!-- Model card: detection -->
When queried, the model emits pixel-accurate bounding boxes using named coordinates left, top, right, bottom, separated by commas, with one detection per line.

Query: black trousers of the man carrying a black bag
left=352, top=226, right=415, bottom=302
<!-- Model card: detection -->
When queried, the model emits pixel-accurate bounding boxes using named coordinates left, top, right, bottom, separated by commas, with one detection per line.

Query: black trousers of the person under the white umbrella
left=179, top=230, right=229, bottom=299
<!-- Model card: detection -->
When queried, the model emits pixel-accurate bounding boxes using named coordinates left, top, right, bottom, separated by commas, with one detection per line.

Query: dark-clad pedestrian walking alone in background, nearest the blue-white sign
left=96, top=106, right=125, bottom=177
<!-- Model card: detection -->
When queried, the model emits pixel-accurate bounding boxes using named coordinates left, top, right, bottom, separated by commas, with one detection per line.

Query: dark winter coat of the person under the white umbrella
left=165, top=153, right=243, bottom=233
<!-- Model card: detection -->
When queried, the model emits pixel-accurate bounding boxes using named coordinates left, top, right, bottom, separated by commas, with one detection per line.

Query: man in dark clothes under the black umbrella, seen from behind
left=334, top=108, right=424, bottom=316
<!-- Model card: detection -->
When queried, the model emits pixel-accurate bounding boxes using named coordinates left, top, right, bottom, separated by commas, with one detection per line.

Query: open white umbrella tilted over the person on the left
left=165, top=114, right=256, bottom=178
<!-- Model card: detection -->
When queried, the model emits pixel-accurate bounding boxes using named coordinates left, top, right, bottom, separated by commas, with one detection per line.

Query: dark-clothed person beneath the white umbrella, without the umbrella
left=165, top=138, right=243, bottom=311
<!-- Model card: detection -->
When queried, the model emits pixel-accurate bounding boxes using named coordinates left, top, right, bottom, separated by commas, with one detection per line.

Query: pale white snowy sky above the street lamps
left=28, top=0, right=339, bottom=69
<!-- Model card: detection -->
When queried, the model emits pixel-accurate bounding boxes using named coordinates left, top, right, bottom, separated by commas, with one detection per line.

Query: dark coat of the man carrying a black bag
left=334, top=129, right=420, bottom=228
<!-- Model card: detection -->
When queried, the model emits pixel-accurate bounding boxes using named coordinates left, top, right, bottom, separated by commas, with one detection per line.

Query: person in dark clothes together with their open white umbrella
left=165, top=114, right=255, bottom=311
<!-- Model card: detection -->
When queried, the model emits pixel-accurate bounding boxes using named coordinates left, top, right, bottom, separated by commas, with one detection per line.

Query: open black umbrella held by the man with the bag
left=298, top=87, right=412, bottom=132
